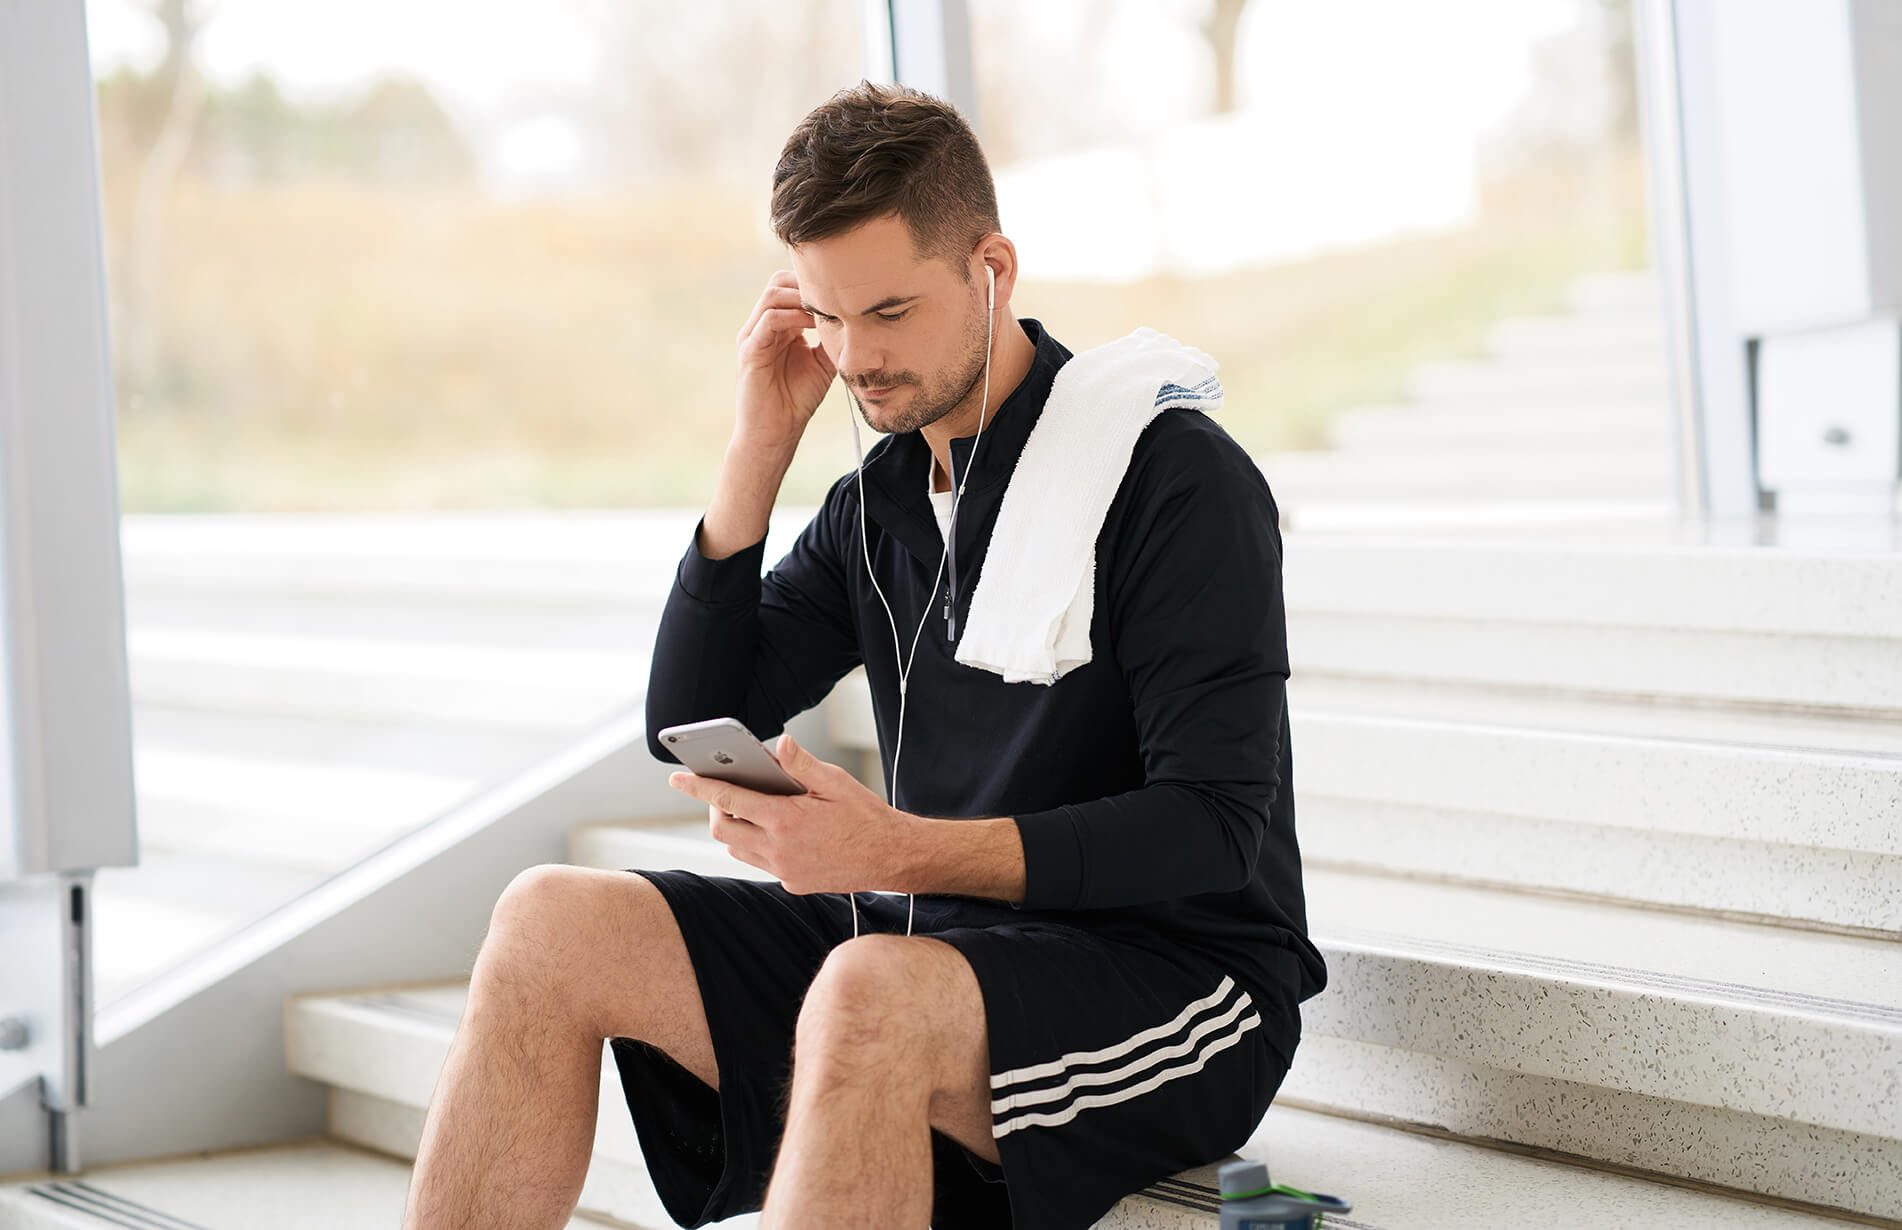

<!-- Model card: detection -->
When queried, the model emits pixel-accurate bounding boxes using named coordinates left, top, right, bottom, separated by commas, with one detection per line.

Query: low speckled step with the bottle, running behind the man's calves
left=281, top=983, right=1856, bottom=1230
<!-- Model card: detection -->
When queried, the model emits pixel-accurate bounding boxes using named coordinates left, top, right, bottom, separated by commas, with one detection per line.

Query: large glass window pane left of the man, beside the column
left=87, top=0, right=864, bottom=1002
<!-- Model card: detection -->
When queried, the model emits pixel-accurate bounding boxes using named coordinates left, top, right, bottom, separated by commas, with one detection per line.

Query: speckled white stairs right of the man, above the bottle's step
left=787, top=534, right=1902, bottom=1224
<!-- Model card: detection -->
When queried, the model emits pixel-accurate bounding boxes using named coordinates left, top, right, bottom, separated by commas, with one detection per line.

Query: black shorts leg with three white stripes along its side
left=920, top=918, right=1288, bottom=1228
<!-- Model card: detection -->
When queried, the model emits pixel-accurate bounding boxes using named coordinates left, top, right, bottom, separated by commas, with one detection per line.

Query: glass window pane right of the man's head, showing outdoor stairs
left=970, top=0, right=1672, bottom=527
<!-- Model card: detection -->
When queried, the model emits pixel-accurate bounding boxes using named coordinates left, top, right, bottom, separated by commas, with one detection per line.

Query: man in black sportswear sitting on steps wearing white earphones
left=405, top=84, right=1326, bottom=1230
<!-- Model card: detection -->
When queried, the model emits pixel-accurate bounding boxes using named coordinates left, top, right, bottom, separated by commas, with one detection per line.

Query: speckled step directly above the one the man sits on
left=829, top=631, right=1902, bottom=935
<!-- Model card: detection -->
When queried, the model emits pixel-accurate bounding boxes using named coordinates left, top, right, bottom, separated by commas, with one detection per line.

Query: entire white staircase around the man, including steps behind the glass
left=0, top=276, right=1902, bottom=1230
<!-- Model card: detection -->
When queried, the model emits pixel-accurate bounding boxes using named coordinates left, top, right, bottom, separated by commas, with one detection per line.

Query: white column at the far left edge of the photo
left=0, top=2, right=137, bottom=1169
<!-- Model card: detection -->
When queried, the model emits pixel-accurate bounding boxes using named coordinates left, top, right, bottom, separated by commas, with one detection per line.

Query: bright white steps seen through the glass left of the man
left=95, top=509, right=722, bottom=1006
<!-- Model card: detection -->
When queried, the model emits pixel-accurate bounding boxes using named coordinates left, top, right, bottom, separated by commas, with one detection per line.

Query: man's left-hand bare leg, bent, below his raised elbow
left=403, top=863, right=719, bottom=1230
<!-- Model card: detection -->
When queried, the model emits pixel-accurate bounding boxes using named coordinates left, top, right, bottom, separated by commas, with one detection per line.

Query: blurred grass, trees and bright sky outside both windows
left=89, top=0, right=1645, bottom=511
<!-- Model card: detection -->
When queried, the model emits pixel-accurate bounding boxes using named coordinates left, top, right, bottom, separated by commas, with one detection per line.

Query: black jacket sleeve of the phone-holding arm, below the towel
left=1016, top=411, right=1290, bottom=909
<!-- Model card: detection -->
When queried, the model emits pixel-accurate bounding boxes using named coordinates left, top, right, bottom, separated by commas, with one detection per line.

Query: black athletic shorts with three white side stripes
left=611, top=869, right=1291, bottom=1230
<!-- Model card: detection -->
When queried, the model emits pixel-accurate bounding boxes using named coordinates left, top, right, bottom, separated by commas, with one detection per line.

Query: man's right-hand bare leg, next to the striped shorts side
left=761, top=935, right=997, bottom=1230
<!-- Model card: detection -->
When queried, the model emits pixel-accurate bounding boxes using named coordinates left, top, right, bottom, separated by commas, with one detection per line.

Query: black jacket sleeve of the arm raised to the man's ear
left=647, top=475, right=860, bottom=762
